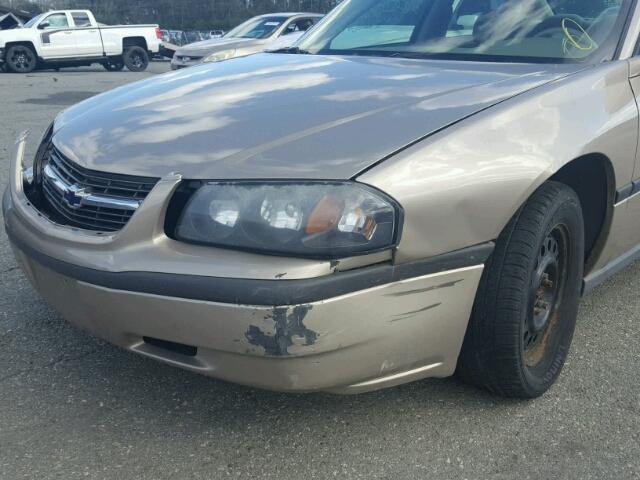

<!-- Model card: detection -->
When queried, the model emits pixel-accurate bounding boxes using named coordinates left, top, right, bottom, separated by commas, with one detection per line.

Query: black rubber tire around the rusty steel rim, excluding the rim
left=457, top=181, right=585, bottom=398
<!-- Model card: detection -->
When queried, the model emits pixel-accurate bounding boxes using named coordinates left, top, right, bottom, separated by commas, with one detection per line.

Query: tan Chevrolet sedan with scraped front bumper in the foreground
left=3, top=0, right=640, bottom=398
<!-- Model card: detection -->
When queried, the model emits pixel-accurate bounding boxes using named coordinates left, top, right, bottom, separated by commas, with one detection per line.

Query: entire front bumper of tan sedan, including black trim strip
left=2, top=132, right=490, bottom=393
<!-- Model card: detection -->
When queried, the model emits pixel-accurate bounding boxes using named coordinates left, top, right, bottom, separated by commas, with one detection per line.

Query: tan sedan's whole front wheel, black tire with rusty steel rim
left=458, top=182, right=584, bottom=399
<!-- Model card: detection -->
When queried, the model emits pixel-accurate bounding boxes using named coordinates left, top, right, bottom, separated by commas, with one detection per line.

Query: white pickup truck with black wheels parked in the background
left=0, top=10, right=162, bottom=73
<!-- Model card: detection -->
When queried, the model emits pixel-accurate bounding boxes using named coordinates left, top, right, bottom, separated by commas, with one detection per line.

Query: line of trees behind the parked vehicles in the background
left=7, top=0, right=340, bottom=30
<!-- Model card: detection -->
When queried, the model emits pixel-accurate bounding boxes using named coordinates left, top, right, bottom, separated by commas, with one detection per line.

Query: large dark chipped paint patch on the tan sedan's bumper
left=245, top=305, right=318, bottom=357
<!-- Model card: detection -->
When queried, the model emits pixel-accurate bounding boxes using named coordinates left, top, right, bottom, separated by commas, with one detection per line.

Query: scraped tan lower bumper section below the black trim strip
left=8, top=238, right=482, bottom=393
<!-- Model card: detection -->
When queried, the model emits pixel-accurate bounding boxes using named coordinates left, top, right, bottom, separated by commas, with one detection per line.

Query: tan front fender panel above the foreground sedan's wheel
left=358, top=61, right=638, bottom=263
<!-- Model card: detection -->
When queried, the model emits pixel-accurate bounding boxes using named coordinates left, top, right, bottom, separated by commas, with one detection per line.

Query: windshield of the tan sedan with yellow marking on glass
left=298, top=0, right=631, bottom=63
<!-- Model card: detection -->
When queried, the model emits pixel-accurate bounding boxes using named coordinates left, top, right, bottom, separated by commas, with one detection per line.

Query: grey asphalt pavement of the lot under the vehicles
left=0, top=63, right=640, bottom=480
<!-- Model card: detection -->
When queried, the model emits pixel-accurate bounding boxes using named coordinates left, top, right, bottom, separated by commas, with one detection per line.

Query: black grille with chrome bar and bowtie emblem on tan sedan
left=42, top=146, right=158, bottom=232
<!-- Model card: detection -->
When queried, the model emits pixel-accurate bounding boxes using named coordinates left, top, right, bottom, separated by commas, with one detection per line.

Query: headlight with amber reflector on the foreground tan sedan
left=174, top=182, right=402, bottom=259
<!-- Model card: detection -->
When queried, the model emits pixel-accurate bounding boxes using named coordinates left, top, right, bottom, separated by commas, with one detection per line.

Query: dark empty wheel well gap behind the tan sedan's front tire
left=550, top=154, right=616, bottom=274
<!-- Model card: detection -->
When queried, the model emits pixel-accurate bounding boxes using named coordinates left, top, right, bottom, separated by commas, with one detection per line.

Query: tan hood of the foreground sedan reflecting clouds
left=53, top=53, right=580, bottom=180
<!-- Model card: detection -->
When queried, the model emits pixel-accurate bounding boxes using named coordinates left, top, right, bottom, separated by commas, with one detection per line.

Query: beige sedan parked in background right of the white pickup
left=171, top=13, right=323, bottom=70
